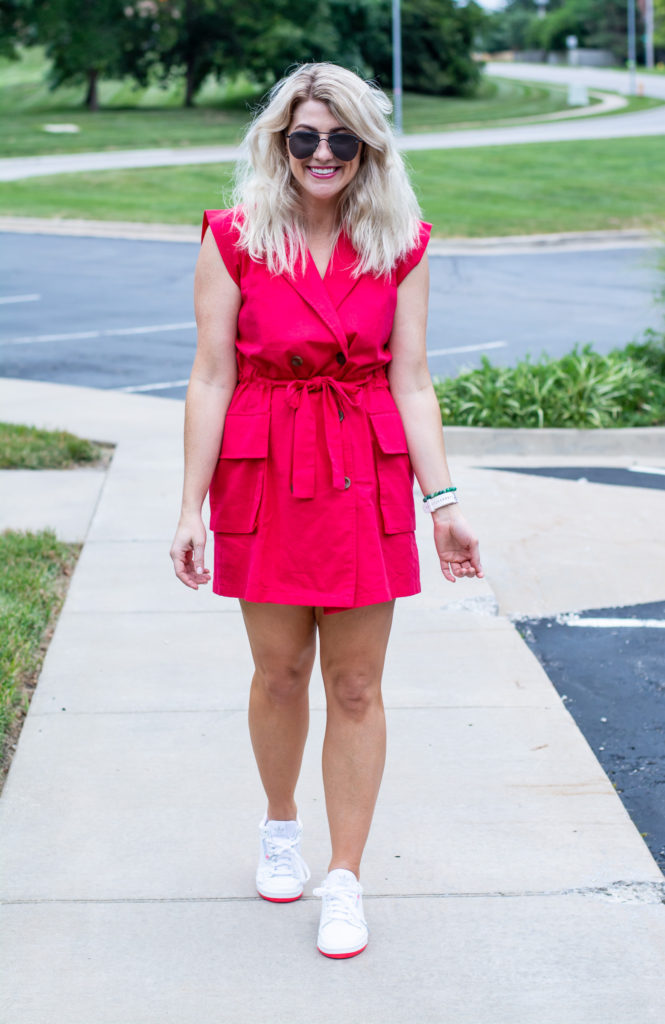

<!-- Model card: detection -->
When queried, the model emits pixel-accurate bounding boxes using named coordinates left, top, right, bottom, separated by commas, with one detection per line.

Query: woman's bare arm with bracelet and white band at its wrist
left=388, top=256, right=483, bottom=583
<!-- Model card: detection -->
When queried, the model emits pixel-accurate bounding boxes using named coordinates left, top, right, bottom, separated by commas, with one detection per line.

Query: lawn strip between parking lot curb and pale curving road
left=0, top=137, right=665, bottom=237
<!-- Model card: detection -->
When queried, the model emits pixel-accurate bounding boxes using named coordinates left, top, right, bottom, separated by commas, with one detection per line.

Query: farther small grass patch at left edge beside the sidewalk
left=0, top=423, right=101, bottom=469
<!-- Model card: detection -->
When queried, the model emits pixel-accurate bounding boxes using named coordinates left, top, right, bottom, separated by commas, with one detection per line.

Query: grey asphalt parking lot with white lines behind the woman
left=0, top=233, right=663, bottom=397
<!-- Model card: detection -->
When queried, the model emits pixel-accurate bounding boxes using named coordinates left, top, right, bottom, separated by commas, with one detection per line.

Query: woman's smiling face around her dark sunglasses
left=287, top=99, right=363, bottom=203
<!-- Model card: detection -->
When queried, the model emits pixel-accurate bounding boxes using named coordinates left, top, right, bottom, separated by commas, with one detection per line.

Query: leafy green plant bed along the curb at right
left=434, top=337, right=665, bottom=428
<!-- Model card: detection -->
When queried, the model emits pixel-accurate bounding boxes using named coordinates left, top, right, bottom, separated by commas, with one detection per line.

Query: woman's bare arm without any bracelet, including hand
left=171, top=230, right=240, bottom=590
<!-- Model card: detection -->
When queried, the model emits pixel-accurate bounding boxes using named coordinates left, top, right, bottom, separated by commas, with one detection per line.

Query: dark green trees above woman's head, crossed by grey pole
left=24, top=0, right=484, bottom=110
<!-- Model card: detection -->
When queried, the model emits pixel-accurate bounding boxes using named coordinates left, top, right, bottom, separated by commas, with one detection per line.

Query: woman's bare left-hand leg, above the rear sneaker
left=240, top=601, right=317, bottom=821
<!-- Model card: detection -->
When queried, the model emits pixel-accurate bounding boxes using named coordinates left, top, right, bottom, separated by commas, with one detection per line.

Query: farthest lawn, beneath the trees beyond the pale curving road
left=0, top=47, right=635, bottom=157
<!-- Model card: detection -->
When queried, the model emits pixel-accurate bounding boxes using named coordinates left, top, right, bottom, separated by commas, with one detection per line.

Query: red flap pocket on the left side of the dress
left=209, top=413, right=271, bottom=534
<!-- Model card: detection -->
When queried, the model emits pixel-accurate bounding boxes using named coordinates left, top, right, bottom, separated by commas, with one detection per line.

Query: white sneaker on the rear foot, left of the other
left=256, top=815, right=309, bottom=903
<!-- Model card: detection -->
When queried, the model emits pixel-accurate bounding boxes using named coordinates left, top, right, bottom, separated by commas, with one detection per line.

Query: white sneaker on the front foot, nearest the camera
left=314, top=867, right=369, bottom=959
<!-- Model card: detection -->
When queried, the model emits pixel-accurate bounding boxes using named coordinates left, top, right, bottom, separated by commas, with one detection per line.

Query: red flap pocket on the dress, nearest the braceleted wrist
left=370, top=410, right=416, bottom=534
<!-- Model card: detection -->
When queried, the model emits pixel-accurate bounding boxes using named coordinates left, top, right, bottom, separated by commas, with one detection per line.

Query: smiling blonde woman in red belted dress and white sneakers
left=171, top=63, right=483, bottom=958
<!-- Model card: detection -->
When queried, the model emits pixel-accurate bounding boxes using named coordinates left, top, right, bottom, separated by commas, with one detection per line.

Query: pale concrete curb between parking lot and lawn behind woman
left=0, top=216, right=665, bottom=256
